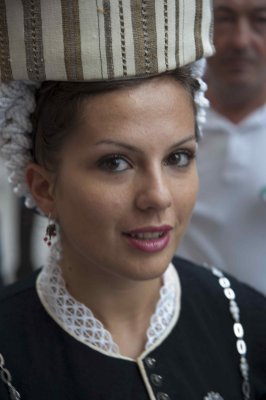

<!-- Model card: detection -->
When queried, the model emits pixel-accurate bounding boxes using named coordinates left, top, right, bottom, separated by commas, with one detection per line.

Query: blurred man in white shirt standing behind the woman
left=178, top=0, right=266, bottom=295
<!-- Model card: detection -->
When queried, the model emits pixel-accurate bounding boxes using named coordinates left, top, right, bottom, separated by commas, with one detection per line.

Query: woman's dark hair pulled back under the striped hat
left=32, top=66, right=199, bottom=171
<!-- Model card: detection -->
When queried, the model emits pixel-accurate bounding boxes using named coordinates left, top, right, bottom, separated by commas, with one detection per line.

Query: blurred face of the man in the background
left=208, top=0, right=266, bottom=89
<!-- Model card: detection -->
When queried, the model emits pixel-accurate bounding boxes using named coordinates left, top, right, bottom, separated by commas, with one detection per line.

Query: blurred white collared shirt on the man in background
left=177, top=106, right=266, bottom=295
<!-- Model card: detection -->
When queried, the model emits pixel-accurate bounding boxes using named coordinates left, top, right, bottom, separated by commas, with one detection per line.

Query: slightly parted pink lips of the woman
left=124, top=225, right=172, bottom=253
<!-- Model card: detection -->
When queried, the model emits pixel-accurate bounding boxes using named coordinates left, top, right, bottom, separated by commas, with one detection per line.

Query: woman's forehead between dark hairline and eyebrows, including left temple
left=59, top=78, right=195, bottom=162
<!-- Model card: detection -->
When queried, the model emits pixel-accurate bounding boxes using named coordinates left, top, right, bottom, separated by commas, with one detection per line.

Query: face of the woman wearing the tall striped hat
left=55, top=78, right=198, bottom=281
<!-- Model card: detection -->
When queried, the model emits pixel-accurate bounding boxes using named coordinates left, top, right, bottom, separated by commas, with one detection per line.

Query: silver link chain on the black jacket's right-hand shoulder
left=211, top=267, right=250, bottom=400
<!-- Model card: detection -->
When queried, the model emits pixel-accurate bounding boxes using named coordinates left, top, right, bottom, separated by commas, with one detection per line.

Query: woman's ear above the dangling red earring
left=25, top=163, right=55, bottom=217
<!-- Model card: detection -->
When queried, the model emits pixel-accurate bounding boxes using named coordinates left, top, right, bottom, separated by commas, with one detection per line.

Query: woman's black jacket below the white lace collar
left=0, top=258, right=266, bottom=400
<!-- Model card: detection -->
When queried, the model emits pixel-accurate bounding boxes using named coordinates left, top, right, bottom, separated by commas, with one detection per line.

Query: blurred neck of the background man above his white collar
left=207, top=83, right=266, bottom=124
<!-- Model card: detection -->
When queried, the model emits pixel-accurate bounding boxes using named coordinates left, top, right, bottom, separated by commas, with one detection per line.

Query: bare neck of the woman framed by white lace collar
left=61, top=253, right=162, bottom=359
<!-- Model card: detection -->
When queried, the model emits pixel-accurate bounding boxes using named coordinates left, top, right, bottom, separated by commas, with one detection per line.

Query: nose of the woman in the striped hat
left=136, top=170, right=172, bottom=211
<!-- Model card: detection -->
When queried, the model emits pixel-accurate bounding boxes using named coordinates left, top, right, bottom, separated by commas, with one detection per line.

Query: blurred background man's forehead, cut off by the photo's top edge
left=214, top=0, right=266, bottom=13
